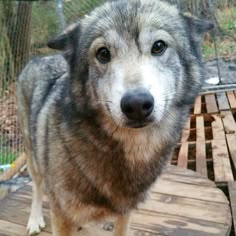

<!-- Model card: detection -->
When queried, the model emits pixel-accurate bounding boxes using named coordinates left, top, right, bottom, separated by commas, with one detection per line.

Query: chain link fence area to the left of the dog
left=0, top=0, right=103, bottom=175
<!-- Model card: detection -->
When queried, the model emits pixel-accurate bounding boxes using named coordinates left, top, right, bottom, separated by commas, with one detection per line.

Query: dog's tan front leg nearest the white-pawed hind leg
left=51, top=207, right=77, bottom=236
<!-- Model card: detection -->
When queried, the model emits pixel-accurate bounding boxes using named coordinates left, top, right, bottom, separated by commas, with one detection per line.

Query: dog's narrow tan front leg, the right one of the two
left=114, top=213, right=130, bottom=236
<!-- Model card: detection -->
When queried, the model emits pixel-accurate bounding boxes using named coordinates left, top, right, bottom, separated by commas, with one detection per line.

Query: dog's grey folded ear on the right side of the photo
left=182, top=14, right=214, bottom=41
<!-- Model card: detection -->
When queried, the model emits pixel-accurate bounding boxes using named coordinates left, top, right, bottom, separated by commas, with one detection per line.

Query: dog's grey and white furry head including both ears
left=48, top=0, right=213, bottom=128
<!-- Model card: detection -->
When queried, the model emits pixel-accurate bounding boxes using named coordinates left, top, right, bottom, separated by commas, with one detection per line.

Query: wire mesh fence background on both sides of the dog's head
left=0, top=0, right=236, bottom=171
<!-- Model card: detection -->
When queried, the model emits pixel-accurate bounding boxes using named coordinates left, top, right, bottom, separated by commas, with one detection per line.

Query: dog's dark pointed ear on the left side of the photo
left=47, top=23, right=79, bottom=60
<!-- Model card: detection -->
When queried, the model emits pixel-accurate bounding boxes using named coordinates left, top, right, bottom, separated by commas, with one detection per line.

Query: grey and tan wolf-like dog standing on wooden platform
left=17, top=0, right=213, bottom=236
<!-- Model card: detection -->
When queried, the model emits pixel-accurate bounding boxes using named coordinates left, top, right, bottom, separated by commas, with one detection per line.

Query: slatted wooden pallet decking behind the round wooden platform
left=172, top=91, right=236, bottom=184
